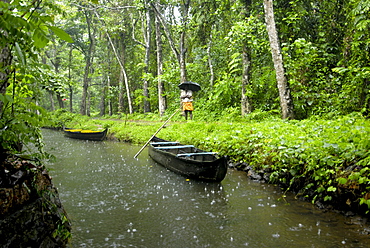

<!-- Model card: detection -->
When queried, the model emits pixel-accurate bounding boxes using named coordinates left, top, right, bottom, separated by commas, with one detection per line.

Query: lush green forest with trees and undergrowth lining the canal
left=0, top=0, right=370, bottom=243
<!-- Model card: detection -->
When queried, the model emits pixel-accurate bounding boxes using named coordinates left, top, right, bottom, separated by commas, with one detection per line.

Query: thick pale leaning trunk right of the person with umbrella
left=263, top=0, right=294, bottom=119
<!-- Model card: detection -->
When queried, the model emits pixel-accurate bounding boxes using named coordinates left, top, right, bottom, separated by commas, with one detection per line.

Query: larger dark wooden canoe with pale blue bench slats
left=148, top=137, right=228, bottom=182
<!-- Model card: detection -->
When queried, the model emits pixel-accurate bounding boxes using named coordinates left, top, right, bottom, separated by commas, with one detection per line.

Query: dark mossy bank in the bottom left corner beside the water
left=0, top=157, right=71, bottom=248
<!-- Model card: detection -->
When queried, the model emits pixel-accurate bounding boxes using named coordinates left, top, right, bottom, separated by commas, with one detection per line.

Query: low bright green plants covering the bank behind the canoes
left=48, top=110, right=370, bottom=215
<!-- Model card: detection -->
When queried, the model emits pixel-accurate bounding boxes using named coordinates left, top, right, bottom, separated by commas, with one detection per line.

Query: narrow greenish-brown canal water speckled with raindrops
left=43, top=130, right=370, bottom=248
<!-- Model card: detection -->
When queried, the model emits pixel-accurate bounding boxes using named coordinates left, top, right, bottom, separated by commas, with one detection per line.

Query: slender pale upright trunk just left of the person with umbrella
left=155, top=3, right=167, bottom=116
